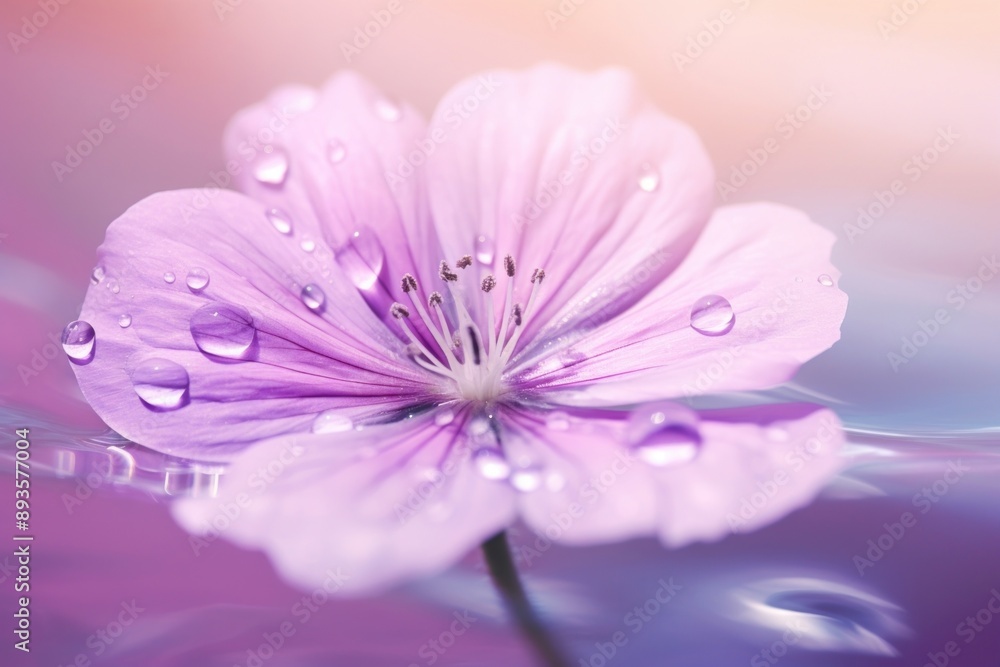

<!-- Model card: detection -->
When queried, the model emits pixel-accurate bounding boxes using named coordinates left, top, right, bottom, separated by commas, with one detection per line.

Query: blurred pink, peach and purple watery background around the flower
left=0, top=0, right=1000, bottom=667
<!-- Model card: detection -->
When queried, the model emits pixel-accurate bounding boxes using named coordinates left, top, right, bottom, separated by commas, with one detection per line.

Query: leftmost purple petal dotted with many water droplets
left=74, top=190, right=431, bottom=458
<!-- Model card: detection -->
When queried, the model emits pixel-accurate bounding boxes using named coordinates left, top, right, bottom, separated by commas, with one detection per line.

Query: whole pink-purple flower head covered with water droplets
left=67, top=66, right=847, bottom=593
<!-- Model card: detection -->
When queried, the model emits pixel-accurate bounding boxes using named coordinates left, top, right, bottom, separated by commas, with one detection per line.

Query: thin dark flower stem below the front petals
left=483, top=531, right=569, bottom=667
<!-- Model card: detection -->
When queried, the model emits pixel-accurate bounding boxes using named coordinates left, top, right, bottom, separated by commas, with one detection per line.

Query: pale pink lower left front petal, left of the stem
left=174, top=411, right=515, bottom=595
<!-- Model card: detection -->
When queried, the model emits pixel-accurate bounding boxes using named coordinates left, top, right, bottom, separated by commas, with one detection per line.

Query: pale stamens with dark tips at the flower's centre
left=389, top=255, right=545, bottom=402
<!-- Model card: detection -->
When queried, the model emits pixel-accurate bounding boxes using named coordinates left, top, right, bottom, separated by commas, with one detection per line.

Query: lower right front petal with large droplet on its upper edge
left=507, top=404, right=844, bottom=547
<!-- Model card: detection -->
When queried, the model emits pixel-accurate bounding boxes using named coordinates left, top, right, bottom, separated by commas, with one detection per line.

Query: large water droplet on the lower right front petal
left=627, top=401, right=701, bottom=467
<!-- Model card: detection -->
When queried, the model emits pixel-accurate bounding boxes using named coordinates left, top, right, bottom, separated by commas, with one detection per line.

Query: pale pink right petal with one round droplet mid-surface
left=512, top=204, right=847, bottom=405
